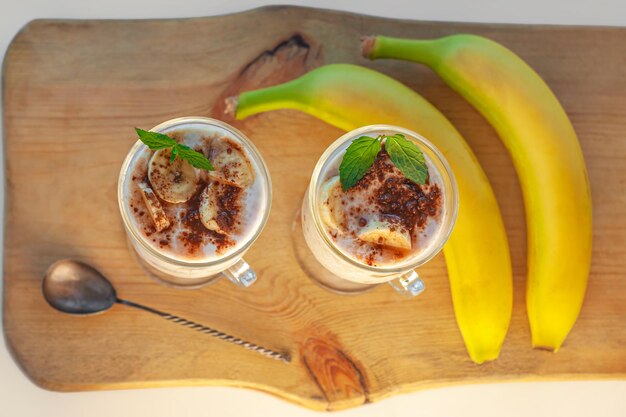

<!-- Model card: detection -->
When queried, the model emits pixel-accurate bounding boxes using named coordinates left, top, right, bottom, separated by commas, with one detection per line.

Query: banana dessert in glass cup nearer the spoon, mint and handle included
left=118, top=118, right=271, bottom=286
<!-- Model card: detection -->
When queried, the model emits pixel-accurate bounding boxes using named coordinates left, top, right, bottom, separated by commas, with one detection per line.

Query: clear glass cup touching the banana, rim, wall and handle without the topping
left=300, top=125, right=458, bottom=296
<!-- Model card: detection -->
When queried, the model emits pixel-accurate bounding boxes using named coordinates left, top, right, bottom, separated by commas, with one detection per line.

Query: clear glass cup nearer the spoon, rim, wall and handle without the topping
left=117, top=117, right=272, bottom=288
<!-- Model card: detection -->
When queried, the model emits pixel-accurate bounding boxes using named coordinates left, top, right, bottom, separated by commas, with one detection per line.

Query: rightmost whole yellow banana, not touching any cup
left=363, top=35, right=592, bottom=352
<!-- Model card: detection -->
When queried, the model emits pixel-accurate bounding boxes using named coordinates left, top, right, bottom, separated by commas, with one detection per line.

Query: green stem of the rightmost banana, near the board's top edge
left=361, top=35, right=446, bottom=67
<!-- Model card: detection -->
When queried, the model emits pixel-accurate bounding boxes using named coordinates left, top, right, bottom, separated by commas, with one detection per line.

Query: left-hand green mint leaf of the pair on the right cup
left=339, top=136, right=381, bottom=191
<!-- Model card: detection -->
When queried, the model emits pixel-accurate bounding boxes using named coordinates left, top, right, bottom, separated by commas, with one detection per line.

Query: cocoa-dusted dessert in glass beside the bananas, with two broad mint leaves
left=302, top=125, right=458, bottom=291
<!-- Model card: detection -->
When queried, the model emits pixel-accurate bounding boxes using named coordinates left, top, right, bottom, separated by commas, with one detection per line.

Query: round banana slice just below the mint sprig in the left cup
left=148, top=149, right=198, bottom=203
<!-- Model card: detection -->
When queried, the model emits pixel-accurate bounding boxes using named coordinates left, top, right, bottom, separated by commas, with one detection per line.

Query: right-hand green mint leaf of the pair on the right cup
left=385, top=134, right=428, bottom=184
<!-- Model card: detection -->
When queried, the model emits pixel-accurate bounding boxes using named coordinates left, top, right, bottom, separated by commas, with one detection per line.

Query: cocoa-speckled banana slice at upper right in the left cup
left=210, top=139, right=254, bottom=188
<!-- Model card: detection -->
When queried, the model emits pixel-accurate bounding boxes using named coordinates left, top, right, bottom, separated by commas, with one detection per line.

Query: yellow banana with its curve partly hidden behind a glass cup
left=230, top=64, right=513, bottom=363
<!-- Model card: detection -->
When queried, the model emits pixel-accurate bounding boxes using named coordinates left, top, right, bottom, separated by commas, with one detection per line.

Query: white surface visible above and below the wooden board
left=0, top=0, right=626, bottom=417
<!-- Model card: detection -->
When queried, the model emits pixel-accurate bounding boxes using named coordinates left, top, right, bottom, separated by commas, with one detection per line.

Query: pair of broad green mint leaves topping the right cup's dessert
left=339, top=133, right=428, bottom=191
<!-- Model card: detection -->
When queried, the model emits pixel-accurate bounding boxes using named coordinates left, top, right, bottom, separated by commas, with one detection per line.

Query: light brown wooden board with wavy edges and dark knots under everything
left=3, top=7, right=626, bottom=410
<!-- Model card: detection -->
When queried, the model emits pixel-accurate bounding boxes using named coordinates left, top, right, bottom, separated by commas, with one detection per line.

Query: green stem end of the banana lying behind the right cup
left=231, top=79, right=301, bottom=120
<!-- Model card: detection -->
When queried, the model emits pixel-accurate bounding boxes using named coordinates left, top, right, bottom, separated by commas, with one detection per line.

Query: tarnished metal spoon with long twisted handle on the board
left=42, top=259, right=291, bottom=363
